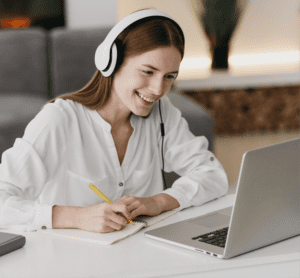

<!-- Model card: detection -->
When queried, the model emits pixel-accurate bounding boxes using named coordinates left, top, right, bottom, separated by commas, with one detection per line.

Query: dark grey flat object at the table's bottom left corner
left=0, top=232, right=26, bottom=256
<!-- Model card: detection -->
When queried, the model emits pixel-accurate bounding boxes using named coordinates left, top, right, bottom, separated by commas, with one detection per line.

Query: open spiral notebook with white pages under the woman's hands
left=39, top=210, right=177, bottom=245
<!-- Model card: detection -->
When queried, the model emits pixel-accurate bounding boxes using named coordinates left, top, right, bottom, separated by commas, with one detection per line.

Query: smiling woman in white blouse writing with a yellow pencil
left=0, top=10, right=228, bottom=233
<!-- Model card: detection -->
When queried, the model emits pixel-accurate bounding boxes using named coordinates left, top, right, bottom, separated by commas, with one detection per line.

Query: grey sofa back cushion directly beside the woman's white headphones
left=50, top=28, right=110, bottom=97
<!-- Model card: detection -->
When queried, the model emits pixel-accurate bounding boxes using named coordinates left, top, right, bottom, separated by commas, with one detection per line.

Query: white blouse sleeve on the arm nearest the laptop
left=158, top=98, right=228, bottom=210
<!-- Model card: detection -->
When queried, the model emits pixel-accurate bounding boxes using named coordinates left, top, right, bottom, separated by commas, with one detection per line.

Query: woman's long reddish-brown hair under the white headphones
left=48, top=14, right=184, bottom=110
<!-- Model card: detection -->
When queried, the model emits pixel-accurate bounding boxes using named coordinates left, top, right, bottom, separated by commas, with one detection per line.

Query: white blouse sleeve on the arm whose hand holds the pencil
left=0, top=101, right=66, bottom=231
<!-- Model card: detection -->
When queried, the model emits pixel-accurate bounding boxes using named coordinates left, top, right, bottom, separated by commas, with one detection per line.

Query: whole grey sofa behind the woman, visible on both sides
left=0, top=28, right=213, bottom=186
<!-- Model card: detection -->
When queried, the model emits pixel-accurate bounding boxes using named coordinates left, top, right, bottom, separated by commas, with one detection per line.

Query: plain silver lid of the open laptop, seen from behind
left=224, top=139, right=300, bottom=258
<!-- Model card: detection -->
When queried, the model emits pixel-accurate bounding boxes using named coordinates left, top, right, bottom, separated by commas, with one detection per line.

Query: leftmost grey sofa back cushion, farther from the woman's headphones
left=0, top=28, right=47, bottom=96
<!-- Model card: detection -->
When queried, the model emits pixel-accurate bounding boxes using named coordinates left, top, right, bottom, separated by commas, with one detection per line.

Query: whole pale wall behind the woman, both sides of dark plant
left=66, top=0, right=300, bottom=79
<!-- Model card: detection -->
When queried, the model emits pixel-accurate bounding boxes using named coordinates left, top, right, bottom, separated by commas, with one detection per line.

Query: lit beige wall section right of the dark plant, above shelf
left=229, top=0, right=300, bottom=75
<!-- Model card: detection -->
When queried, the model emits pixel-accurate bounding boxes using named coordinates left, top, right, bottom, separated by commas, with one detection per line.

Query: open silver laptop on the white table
left=145, top=139, right=300, bottom=259
